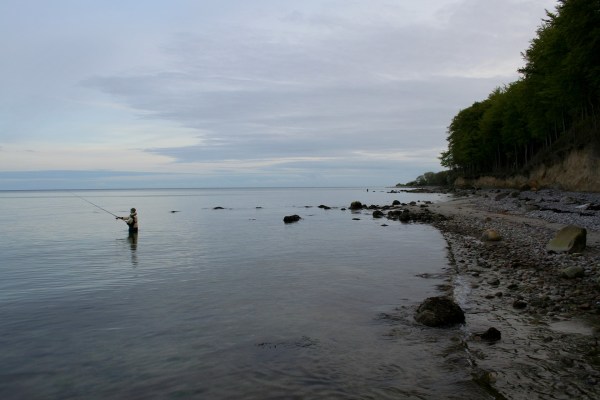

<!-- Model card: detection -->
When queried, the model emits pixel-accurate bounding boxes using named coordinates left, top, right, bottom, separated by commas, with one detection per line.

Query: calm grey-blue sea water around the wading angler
left=0, top=188, right=489, bottom=399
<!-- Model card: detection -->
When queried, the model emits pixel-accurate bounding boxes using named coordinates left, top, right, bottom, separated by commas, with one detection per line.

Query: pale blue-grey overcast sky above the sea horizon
left=0, top=0, right=556, bottom=190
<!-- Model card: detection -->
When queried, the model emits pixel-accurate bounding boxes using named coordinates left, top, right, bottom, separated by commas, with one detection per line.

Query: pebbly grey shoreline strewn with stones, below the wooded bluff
left=428, top=190, right=600, bottom=399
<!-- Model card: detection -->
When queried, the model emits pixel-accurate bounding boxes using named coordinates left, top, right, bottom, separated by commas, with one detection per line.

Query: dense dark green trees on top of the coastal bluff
left=440, top=0, right=600, bottom=177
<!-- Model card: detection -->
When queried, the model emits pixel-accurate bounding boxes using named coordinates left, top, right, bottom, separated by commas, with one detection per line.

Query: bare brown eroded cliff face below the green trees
left=455, top=149, right=600, bottom=192
